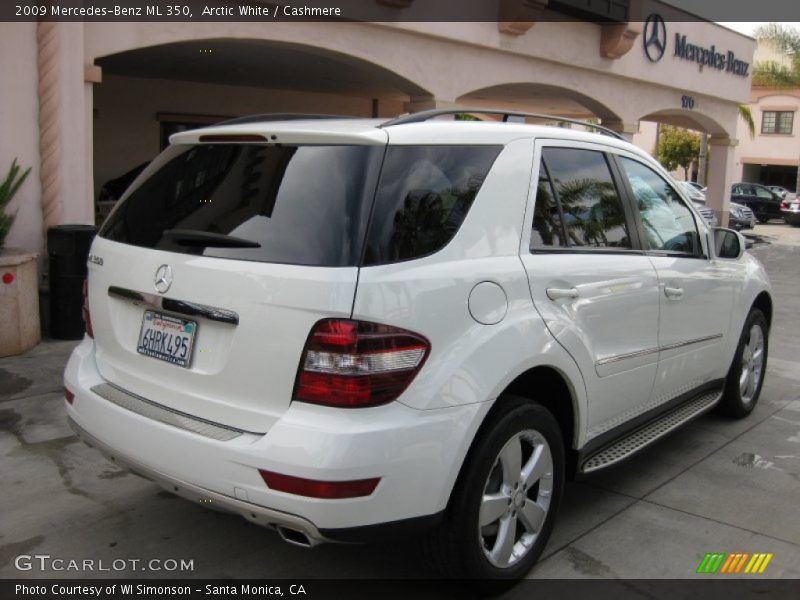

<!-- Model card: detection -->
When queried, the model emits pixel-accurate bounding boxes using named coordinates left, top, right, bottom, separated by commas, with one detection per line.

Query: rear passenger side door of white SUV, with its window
left=521, top=140, right=659, bottom=438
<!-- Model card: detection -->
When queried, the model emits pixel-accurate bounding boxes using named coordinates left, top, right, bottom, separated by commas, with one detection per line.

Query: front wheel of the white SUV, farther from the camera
left=718, top=308, right=769, bottom=419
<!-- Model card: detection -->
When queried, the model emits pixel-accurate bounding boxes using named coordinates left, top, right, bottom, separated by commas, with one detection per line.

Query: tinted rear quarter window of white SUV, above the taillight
left=364, top=146, right=501, bottom=265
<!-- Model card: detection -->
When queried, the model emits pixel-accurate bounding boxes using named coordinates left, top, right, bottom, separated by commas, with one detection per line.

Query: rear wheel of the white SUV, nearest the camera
left=423, top=396, right=565, bottom=589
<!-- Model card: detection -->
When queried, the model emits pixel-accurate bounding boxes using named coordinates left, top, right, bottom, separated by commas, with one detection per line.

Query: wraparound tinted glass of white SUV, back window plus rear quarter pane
left=100, top=144, right=502, bottom=266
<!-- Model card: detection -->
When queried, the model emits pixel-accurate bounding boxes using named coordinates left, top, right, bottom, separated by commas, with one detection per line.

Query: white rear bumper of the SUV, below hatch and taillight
left=64, top=338, right=491, bottom=542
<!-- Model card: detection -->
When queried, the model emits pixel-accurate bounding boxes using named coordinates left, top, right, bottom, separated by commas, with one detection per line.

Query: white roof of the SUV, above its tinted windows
left=170, top=112, right=649, bottom=157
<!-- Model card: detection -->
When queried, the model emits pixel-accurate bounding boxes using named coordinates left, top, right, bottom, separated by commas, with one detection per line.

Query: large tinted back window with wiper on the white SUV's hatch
left=100, top=144, right=383, bottom=266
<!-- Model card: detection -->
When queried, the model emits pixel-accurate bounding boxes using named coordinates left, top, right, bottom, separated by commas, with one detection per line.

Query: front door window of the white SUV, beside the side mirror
left=620, top=157, right=700, bottom=256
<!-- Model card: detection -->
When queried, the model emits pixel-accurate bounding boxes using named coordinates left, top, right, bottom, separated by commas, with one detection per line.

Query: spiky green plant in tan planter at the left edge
left=0, top=159, right=41, bottom=356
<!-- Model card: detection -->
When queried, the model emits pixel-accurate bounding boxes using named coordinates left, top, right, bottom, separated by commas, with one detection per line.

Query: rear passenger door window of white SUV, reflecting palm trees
left=542, top=148, right=631, bottom=248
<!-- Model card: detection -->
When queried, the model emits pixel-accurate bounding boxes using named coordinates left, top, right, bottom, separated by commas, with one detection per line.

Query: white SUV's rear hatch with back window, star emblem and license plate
left=89, top=123, right=386, bottom=432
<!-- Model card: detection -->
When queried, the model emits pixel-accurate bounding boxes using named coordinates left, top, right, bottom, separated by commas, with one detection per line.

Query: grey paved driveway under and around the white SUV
left=0, top=222, right=800, bottom=578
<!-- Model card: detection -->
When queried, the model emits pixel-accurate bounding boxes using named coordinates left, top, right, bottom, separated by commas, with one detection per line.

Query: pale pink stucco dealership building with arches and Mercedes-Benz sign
left=0, top=0, right=755, bottom=252
